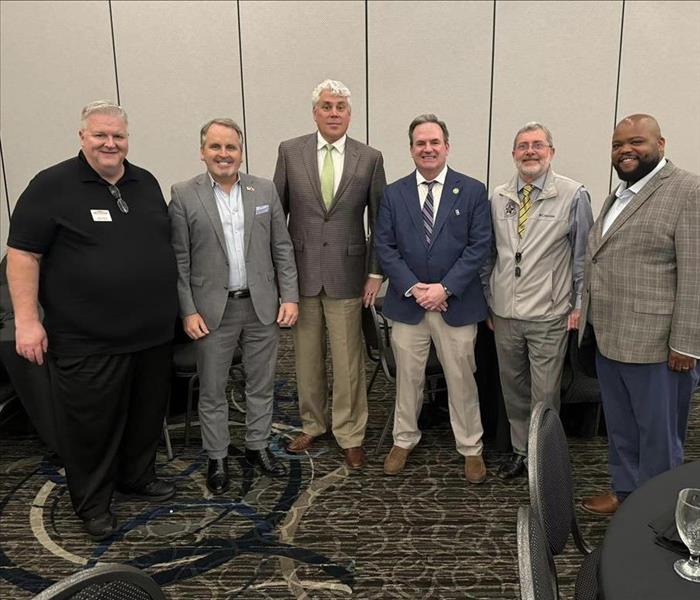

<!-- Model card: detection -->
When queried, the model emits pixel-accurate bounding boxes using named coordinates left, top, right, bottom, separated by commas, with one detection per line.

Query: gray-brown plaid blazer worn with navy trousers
left=579, top=162, right=700, bottom=363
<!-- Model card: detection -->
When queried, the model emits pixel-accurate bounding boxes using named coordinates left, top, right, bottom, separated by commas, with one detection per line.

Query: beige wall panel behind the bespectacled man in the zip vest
left=490, top=2, right=629, bottom=214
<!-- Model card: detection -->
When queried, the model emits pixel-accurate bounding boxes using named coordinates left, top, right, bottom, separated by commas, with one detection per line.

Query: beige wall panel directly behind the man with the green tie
left=240, top=0, right=366, bottom=177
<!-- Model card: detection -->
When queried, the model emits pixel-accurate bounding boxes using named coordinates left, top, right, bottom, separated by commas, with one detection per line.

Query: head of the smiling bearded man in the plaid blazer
left=611, top=114, right=666, bottom=185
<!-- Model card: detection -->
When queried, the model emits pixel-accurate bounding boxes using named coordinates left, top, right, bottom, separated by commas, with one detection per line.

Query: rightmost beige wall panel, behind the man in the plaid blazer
left=613, top=2, right=700, bottom=176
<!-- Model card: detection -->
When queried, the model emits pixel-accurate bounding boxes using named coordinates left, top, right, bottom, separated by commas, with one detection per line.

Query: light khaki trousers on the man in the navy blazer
left=391, top=311, right=483, bottom=456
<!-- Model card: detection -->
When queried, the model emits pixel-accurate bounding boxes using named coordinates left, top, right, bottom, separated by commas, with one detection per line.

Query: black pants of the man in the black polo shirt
left=48, top=343, right=172, bottom=520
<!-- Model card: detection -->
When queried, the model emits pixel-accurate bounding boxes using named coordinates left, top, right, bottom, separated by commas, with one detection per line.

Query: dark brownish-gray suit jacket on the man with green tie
left=274, top=133, right=386, bottom=298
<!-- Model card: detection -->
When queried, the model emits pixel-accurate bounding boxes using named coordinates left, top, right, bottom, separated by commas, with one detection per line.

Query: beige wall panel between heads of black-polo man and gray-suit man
left=112, top=1, right=242, bottom=201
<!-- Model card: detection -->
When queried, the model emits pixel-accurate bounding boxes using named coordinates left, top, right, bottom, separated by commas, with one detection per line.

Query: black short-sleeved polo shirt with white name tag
left=7, top=152, right=177, bottom=355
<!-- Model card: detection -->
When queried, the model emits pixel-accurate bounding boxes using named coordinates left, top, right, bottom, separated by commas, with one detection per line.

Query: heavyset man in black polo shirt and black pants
left=7, top=101, right=177, bottom=540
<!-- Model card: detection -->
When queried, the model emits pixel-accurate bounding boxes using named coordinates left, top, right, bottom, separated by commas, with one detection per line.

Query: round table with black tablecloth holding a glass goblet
left=598, top=461, right=700, bottom=600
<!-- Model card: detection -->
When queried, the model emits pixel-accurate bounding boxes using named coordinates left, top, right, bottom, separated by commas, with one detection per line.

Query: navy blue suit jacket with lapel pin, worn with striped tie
left=374, top=169, right=491, bottom=327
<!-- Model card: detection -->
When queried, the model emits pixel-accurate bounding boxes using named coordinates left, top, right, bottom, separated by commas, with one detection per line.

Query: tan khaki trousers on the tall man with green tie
left=294, top=292, right=367, bottom=448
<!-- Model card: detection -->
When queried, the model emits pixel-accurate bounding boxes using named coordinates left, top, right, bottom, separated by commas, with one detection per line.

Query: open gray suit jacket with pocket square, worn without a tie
left=168, top=173, right=299, bottom=329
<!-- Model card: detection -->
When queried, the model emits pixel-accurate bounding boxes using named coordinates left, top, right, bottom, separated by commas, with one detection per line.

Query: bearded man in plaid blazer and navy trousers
left=579, top=114, right=700, bottom=514
